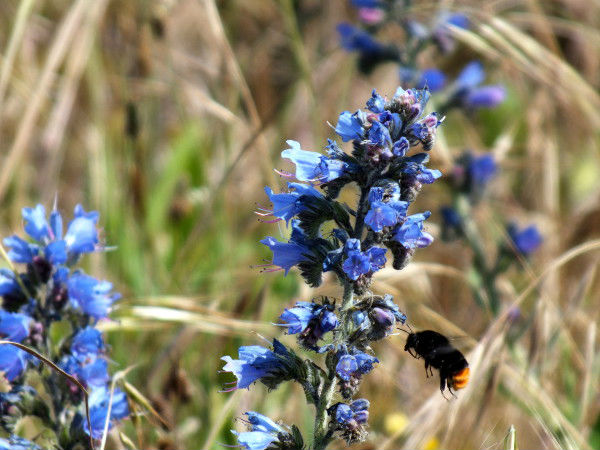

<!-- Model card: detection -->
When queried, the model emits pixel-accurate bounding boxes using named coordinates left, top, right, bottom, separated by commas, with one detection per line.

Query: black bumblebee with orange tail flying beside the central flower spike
left=404, top=330, right=470, bottom=397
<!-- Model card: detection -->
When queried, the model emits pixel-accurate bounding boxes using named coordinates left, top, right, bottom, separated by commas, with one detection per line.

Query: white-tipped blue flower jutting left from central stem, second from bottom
left=221, top=340, right=284, bottom=392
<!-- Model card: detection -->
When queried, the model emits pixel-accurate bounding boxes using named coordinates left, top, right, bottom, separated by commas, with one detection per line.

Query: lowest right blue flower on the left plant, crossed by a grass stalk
left=83, top=387, right=129, bottom=439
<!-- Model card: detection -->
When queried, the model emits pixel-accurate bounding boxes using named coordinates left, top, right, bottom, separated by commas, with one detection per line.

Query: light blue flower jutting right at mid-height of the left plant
left=67, top=272, right=121, bottom=319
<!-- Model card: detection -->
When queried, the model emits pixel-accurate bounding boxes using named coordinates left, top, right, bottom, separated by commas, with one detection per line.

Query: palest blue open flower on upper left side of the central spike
left=281, top=140, right=346, bottom=183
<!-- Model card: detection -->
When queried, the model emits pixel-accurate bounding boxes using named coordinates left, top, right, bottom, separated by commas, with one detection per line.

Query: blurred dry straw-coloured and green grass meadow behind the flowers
left=0, top=0, right=600, bottom=450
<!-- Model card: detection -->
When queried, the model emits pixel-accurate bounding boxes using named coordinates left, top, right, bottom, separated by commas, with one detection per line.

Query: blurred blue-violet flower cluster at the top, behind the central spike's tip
left=337, top=0, right=506, bottom=111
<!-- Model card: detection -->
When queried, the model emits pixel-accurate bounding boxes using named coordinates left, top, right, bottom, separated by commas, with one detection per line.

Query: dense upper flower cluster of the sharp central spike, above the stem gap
left=259, top=88, right=441, bottom=294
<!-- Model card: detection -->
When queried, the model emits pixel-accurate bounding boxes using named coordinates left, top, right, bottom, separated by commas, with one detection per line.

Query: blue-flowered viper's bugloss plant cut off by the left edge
left=0, top=205, right=129, bottom=449
